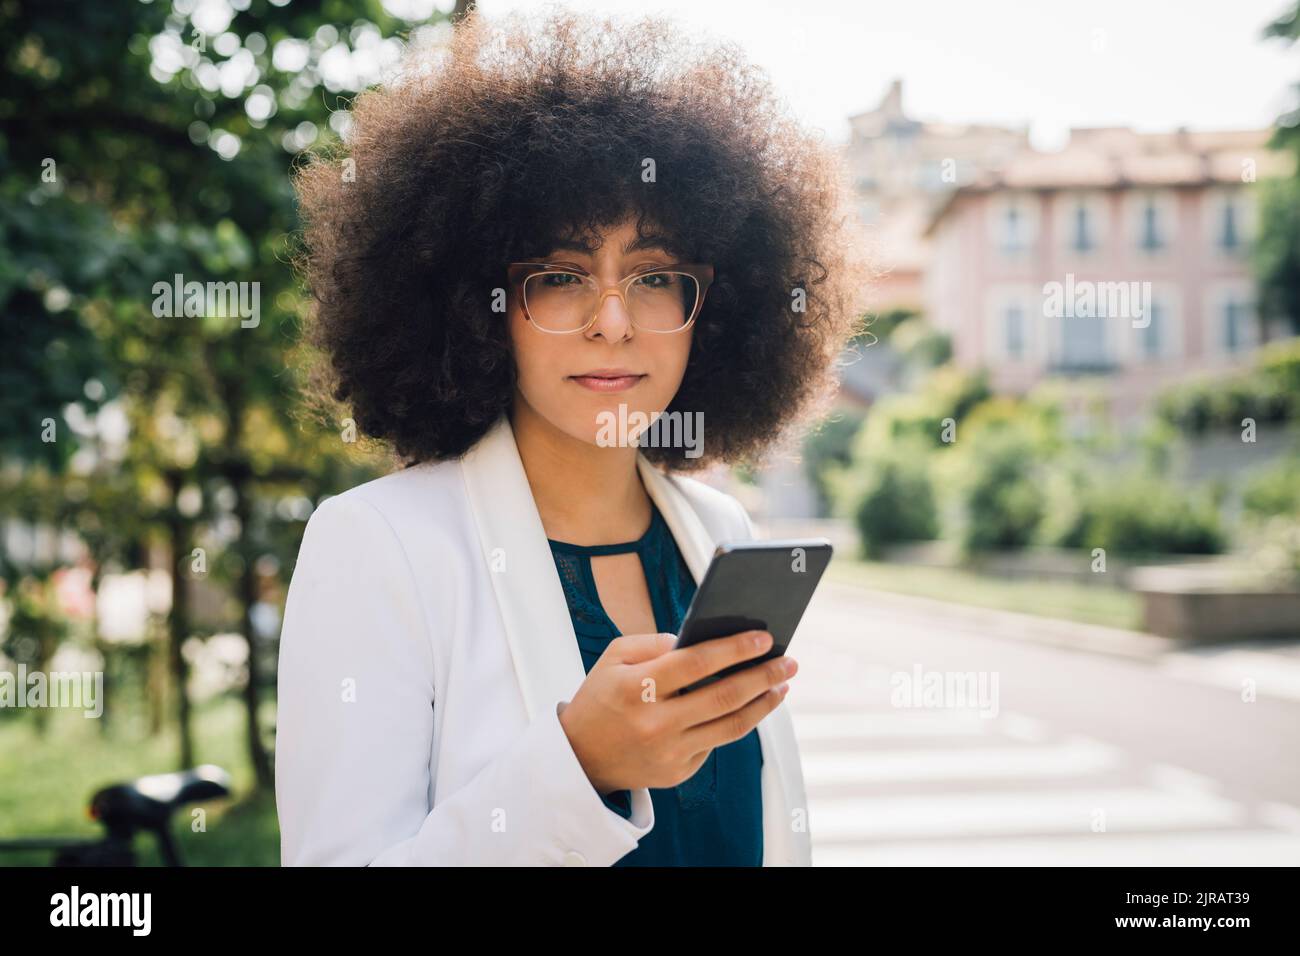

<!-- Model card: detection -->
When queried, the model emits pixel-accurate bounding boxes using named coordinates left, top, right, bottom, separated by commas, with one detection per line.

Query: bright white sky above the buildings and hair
left=478, top=0, right=1300, bottom=150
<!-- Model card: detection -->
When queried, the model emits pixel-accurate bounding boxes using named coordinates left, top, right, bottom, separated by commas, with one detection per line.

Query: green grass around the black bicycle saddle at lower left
left=0, top=697, right=280, bottom=866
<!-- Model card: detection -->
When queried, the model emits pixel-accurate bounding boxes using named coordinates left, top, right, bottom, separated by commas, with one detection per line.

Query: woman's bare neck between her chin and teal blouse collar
left=510, top=392, right=650, bottom=546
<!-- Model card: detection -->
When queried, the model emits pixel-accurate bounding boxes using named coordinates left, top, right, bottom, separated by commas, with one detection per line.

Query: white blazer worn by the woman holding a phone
left=276, top=416, right=811, bottom=866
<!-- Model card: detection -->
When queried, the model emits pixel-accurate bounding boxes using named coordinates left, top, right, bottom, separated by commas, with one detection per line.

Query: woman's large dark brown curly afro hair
left=295, top=8, right=870, bottom=471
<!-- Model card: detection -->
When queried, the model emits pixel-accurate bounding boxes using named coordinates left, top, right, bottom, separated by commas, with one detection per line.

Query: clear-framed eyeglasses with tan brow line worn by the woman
left=507, top=263, right=714, bottom=334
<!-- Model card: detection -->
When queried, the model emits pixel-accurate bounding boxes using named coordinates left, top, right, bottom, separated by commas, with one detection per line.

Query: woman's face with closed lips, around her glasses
left=508, top=220, right=694, bottom=445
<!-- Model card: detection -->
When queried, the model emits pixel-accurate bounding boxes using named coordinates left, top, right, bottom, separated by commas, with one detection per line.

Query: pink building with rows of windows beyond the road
left=924, top=129, right=1290, bottom=418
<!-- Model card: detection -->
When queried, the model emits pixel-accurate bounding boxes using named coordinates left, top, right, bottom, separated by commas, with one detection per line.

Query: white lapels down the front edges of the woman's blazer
left=460, top=415, right=797, bottom=865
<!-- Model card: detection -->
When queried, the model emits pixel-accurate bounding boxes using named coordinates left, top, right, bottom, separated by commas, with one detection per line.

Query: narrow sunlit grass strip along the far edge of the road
left=827, top=558, right=1141, bottom=630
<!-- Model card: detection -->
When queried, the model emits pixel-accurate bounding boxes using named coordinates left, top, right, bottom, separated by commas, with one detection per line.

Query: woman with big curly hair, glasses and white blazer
left=276, top=5, right=863, bottom=865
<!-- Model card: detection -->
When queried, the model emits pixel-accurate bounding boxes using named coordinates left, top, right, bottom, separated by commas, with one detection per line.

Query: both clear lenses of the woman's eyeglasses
left=524, top=272, right=699, bottom=332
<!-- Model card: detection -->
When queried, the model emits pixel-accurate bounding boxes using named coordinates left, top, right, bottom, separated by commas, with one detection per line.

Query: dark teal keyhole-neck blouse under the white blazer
left=550, top=502, right=763, bottom=866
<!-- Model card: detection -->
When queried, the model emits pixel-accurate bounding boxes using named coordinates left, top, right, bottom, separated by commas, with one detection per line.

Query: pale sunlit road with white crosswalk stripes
left=787, top=581, right=1300, bottom=866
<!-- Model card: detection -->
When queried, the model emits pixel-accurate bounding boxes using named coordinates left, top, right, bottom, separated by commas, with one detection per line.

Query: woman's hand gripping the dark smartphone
left=560, top=631, right=798, bottom=795
